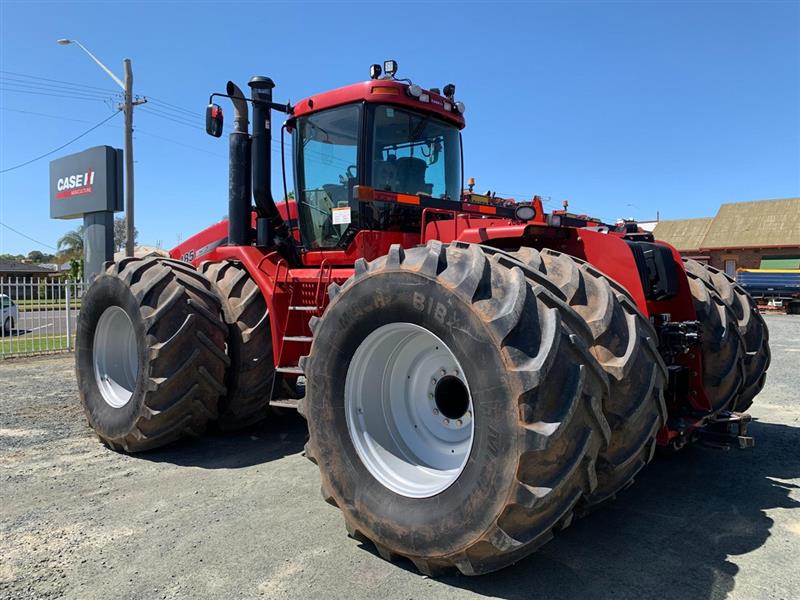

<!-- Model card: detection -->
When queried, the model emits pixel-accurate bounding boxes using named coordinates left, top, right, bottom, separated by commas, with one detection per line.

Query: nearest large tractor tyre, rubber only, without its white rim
left=300, top=242, right=610, bottom=576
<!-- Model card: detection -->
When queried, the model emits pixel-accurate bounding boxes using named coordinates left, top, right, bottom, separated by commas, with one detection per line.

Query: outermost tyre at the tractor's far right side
left=683, top=258, right=771, bottom=412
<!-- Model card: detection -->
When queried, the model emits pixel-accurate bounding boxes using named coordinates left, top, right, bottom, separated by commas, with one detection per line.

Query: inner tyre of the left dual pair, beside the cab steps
left=200, top=261, right=278, bottom=431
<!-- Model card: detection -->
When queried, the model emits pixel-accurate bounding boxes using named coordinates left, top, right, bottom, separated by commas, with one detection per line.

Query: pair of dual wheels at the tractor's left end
left=76, top=257, right=274, bottom=452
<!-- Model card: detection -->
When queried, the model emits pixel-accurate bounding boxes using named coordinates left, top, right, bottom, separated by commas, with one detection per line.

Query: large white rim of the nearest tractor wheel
left=344, top=323, right=475, bottom=498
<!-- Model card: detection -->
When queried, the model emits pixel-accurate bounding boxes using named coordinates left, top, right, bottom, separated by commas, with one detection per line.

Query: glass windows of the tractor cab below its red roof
left=294, top=104, right=461, bottom=250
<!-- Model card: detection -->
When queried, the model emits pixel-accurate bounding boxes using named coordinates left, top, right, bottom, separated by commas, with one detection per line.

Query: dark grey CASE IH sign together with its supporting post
left=50, top=146, right=123, bottom=282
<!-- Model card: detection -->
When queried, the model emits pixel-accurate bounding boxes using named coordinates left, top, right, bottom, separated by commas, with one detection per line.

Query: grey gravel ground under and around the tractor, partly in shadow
left=0, top=315, right=800, bottom=600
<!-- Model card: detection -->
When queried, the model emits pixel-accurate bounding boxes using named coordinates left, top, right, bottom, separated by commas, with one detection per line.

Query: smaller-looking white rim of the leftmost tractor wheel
left=92, top=306, right=139, bottom=408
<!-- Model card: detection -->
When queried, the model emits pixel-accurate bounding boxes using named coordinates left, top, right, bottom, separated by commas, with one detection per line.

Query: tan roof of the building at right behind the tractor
left=653, top=198, right=800, bottom=251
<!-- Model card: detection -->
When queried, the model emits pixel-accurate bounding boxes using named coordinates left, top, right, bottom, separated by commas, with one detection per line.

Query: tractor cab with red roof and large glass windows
left=287, top=67, right=464, bottom=250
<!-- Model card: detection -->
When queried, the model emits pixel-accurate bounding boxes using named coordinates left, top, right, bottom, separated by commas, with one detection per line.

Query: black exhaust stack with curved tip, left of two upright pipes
left=226, top=81, right=250, bottom=246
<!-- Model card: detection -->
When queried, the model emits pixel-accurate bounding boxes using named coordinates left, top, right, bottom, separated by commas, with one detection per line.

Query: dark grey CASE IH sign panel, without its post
left=50, top=146, right=122, bottom=219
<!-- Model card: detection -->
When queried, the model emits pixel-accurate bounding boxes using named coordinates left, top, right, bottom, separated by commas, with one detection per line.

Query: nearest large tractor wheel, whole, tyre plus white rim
left=299, top=242, right=610, bottom=575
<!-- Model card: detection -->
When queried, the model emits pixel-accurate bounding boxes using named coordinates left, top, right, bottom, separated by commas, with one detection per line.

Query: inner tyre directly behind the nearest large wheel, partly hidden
left=511, top=248, right=667, bottom=505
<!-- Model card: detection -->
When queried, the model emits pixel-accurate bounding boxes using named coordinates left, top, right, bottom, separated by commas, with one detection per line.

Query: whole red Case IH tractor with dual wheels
left=76, top=61, right=770, bottom=575
